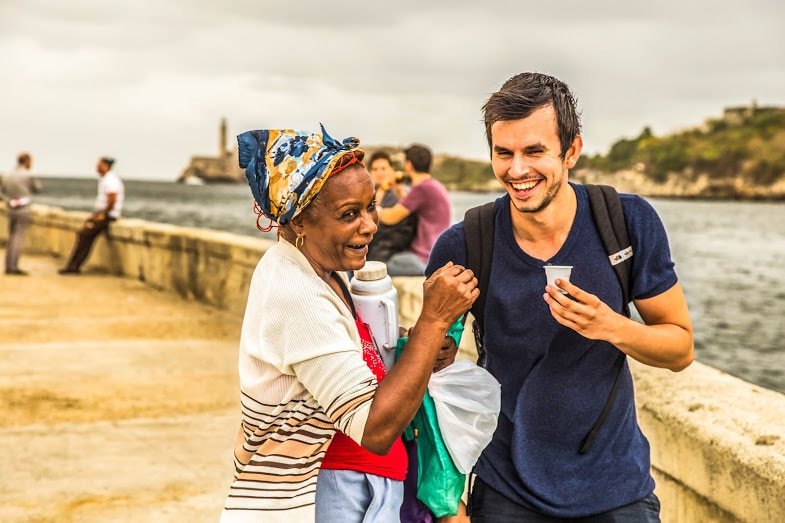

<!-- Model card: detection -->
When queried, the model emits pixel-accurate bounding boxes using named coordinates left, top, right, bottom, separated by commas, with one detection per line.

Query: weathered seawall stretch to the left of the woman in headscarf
left=0, top=205, right=272, bottom=311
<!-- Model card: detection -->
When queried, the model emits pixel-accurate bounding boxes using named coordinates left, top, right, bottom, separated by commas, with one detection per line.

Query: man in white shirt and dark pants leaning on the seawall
left=59, top=157, right=125, bottom=274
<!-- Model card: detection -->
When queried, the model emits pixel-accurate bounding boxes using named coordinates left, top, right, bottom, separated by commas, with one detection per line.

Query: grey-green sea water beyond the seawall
left=36, top=178, right=785, bottom=392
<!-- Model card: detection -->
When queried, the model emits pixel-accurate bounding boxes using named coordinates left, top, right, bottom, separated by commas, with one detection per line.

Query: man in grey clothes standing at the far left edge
left=0, top=152, right=41, bottom=276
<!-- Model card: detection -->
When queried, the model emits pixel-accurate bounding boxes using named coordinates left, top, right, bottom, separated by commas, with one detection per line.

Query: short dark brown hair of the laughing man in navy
left=482, top=73, right=581, bottom=158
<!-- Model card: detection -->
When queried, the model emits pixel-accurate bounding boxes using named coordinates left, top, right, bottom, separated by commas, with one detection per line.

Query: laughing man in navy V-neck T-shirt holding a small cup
left=426, top=73, right=693, bottom=523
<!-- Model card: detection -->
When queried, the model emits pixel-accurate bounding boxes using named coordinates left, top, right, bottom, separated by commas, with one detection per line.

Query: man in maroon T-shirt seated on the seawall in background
left=376, top=144, right=452, bottom=276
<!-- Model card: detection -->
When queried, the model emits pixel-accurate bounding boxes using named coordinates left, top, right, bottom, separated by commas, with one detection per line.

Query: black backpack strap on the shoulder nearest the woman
left=463, top=202, right=496, bottom=366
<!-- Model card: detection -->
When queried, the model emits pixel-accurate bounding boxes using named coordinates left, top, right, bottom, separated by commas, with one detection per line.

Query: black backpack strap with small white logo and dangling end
left=578, top=184, right=633, bottom=454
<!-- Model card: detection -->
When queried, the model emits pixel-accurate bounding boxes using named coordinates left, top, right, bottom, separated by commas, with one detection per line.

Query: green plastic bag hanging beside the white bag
left=396, top=322, right=466, bottom=517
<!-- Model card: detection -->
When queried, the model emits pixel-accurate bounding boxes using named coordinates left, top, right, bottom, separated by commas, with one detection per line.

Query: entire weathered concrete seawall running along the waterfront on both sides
left=0, top=206, right=785, bottom=522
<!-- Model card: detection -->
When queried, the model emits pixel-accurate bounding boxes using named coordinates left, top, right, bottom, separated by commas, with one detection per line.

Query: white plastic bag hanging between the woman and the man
left=428, top=360, right=501, bottom=474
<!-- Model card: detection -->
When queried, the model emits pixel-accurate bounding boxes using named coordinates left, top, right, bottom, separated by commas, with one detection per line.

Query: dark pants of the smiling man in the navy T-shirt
left=471, top=478, right=660, bottom=523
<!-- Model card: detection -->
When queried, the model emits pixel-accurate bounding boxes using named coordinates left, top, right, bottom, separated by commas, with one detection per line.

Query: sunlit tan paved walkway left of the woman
left=0, top=251, right=241, bottom=522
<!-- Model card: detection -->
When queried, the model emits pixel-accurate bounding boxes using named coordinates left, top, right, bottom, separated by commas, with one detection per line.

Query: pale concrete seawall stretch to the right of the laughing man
left=634, top=362, right=785, bottom=522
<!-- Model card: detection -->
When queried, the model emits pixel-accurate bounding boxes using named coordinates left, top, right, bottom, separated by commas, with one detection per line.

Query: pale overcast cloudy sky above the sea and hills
left=0, top=0, right=785, bottom=180
